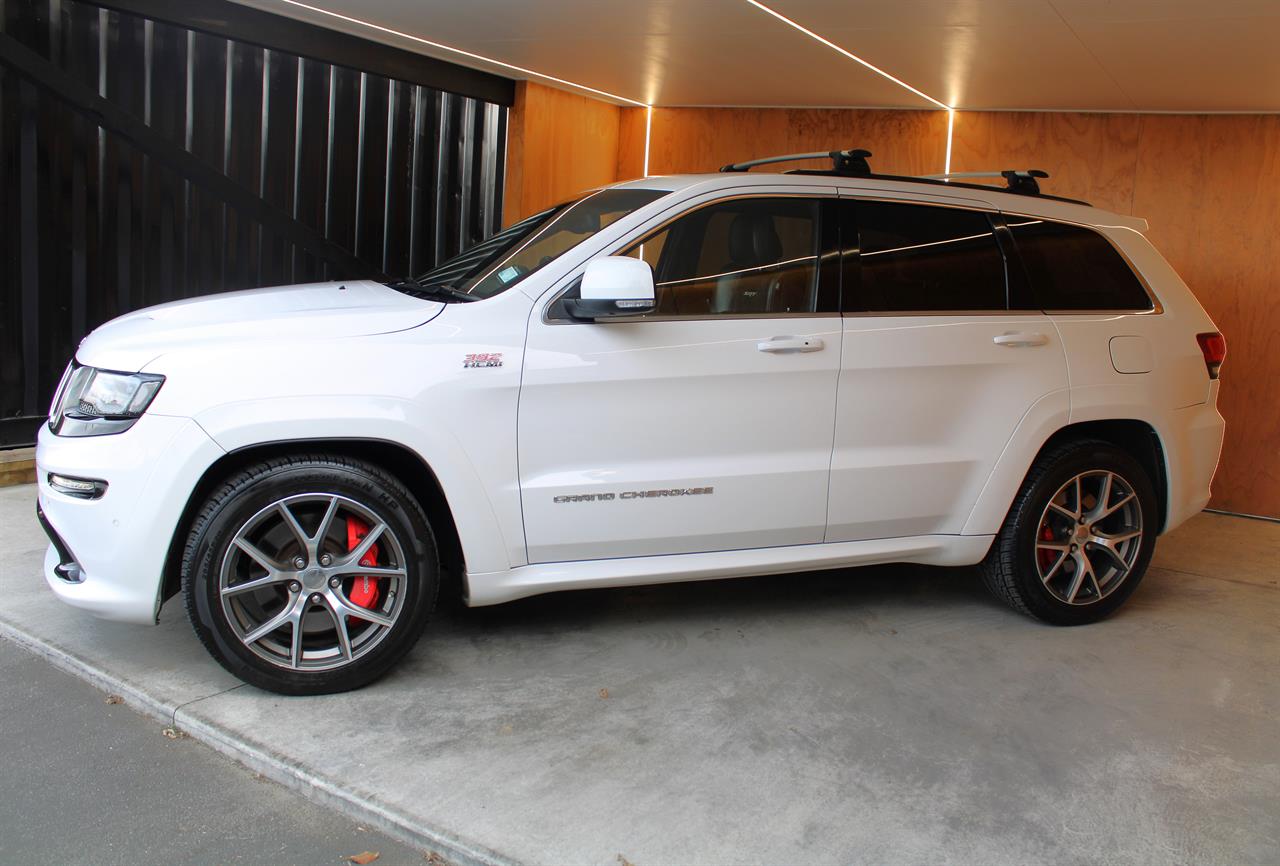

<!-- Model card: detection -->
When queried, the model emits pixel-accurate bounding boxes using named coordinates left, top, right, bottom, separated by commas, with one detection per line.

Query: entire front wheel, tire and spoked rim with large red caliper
left=183, top=454, right=439, bottom=695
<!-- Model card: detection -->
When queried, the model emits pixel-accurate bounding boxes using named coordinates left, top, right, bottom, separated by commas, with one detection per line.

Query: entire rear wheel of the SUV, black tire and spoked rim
left=982, top=440, right=1157, bottom=626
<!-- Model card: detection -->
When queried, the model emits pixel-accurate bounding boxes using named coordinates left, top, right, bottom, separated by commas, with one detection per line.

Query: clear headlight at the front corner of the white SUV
left=49, top=362, right=164, bottom=436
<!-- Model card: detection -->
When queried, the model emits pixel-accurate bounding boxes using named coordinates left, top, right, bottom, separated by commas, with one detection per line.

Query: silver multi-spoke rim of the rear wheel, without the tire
left=1036, top=469, right=1143, bottom=605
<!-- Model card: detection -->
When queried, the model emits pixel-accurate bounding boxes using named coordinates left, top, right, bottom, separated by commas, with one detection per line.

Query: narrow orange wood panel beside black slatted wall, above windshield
left=503, top=82, right=621, bottom=225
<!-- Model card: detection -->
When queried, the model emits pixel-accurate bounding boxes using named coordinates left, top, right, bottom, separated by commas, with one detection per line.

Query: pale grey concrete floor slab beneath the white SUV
left=0, top=478, right=1280, bottom=866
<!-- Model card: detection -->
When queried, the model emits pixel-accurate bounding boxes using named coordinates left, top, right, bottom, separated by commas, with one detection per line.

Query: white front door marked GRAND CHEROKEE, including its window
left=518, top=196, right=842, bottom=563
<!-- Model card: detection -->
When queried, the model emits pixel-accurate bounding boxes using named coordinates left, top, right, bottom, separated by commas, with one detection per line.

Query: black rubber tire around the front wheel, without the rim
left=182, top=453, right=440, bottom=695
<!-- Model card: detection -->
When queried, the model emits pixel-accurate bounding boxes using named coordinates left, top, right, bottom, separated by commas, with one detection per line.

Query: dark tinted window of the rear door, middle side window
left=846, top=201, right=1007, bottom=312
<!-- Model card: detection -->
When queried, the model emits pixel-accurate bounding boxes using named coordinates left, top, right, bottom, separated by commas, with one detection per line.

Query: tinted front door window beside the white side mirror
left=622, top=198, right=836, bottom=316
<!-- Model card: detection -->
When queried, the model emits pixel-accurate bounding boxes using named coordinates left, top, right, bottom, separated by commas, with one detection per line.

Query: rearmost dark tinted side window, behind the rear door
left=1006, top=216, right=1152, bottom=310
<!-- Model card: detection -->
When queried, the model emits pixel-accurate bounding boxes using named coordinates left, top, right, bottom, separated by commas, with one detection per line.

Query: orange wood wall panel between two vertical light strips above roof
left=649, top=109, right=947, bottom=174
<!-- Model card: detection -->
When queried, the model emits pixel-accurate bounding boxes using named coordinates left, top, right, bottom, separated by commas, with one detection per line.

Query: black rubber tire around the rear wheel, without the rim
left=982, top=439, right=1160, bottom=626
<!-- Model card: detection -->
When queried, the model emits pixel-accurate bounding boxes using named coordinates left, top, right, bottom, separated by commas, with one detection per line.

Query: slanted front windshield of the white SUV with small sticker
left=415, top=189, right=667, bottom=299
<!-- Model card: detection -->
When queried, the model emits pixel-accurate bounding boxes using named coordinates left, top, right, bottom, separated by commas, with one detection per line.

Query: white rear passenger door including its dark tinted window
left=827, top=198, right=1070, bottom=541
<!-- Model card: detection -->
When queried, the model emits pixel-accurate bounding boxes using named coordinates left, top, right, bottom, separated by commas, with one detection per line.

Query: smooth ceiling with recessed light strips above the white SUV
left=242, top=0, right=1280, bottom=113
